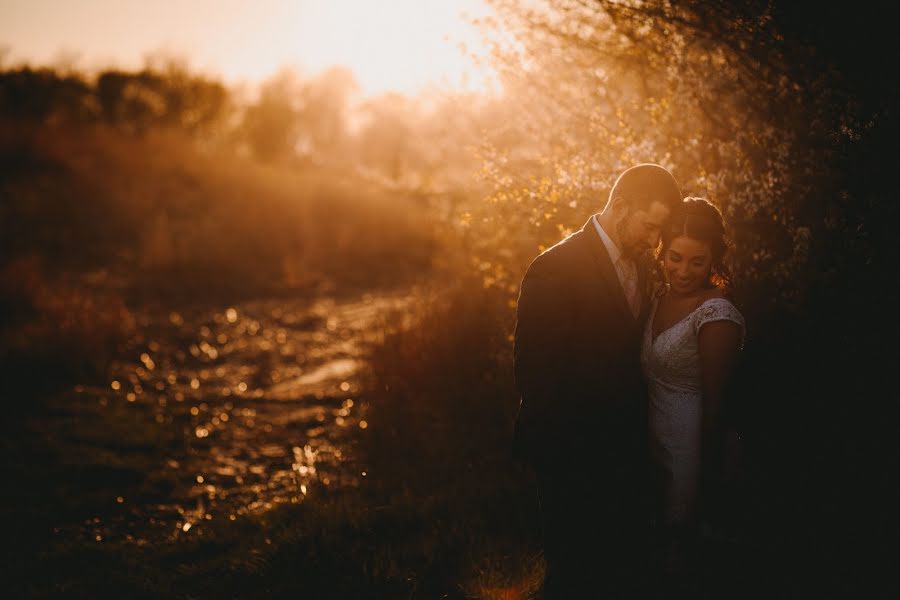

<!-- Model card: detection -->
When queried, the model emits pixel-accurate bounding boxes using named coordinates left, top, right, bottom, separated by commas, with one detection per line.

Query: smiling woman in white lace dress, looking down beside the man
left=641, top=198, right=744, bottom=573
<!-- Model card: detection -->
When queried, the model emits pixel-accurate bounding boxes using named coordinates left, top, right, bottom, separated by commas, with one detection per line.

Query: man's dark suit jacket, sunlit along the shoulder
left=513, top=213, right=650, bottom=472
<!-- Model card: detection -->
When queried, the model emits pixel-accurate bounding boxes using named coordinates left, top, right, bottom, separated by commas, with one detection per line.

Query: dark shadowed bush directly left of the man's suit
left=365, top=277, right=518, bottom=490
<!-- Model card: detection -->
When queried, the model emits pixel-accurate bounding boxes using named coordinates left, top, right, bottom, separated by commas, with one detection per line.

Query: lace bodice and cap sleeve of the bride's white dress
left=641, top=298, right=744, bottom=394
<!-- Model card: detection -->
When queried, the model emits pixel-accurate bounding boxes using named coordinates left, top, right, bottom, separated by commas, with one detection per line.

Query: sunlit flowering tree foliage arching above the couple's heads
left=475, top=0, right=896, bottom=315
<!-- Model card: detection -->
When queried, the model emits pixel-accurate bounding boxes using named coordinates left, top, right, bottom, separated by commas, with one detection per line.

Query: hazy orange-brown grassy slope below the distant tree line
left=0, top=120, right=434, bottom=299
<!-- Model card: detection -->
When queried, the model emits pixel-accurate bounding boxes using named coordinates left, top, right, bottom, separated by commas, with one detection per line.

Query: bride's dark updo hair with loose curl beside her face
left=660, top=197, right=731, bottom=288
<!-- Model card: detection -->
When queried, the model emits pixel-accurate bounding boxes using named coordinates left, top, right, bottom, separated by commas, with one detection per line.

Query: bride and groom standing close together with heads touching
left=514, top=163, right=744, bottom=599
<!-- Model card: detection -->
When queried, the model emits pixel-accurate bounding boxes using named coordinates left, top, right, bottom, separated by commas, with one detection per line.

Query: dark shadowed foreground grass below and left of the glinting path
left=3, top=382, right=542, bottom=598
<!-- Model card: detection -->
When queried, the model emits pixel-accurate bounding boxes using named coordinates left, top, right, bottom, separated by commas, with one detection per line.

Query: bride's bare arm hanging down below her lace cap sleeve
left=698, top=321, right=742, bottom=516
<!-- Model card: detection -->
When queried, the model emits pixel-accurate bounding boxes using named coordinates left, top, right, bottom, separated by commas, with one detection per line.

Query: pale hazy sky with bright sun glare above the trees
left=0, top=0, right=487, bottom=94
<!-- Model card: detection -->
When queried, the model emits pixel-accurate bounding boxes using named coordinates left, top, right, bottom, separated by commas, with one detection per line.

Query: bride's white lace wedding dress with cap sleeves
left=641, top=298, right=744, bottom=525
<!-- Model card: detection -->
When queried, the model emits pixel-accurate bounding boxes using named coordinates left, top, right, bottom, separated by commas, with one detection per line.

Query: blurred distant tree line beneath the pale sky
left=0, top=60, right=496, bottom=191
